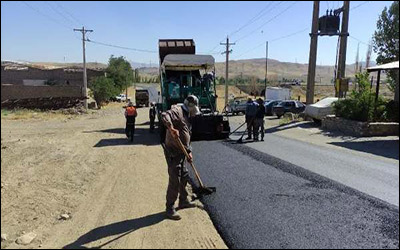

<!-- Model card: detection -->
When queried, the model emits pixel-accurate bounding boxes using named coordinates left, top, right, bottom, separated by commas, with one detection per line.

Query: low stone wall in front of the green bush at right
left=322, top=115, right=399, bottom=137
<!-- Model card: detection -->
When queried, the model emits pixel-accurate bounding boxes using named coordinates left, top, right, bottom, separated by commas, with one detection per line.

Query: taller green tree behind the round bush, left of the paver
left=106, top=56, right=133, bottom=92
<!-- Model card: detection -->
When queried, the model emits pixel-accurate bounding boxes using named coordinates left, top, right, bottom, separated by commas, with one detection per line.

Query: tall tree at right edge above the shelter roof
left=373, top=1, right=399, bottom=91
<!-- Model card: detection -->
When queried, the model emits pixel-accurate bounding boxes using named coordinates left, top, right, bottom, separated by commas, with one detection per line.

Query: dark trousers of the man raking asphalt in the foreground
left=165, top=153, right=189, bottom=210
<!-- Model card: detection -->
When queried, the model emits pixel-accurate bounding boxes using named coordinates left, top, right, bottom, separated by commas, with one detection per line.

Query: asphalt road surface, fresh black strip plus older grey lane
left=193, top=123, right=399, bottom=248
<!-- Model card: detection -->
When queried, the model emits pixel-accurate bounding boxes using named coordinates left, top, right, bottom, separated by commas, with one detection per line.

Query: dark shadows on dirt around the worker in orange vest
left=86, top=128, right=160, bottom=148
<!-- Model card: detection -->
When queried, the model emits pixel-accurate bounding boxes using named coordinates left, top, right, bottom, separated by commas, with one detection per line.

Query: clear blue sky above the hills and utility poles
left=1, top=1, right=392, bottom=65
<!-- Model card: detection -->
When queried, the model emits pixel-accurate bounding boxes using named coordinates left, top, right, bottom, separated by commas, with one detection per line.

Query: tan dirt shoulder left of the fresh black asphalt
left=1, top=107, right=226, bottom=248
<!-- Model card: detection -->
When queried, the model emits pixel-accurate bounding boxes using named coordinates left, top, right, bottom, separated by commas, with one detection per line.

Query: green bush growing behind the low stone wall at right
left=334, top=73, right=395, bottom=122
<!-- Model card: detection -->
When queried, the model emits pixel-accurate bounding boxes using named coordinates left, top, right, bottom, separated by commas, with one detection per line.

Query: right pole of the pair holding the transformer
left=337, top=1, right=350, bottom=98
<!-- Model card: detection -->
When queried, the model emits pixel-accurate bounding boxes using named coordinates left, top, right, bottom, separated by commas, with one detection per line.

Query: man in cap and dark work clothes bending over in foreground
left=162, top=95, right=200, bottom=220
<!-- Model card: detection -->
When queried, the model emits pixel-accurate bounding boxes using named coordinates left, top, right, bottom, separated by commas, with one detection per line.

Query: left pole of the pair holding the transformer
left=306, top=1, right=319, bottom=104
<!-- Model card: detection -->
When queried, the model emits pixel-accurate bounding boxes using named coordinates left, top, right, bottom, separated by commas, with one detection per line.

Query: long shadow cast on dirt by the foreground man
left=63, top=212, right=166, bottom=249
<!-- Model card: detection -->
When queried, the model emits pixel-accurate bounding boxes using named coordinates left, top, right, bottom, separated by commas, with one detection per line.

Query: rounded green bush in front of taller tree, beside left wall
left=90, top=76, right=119, bottom=107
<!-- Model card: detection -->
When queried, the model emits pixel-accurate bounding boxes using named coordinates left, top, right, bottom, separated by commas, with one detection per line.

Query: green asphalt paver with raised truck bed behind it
left=157, top=39, right=230, bottom=140
